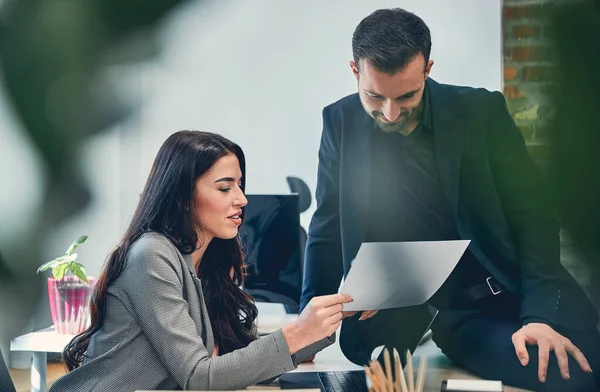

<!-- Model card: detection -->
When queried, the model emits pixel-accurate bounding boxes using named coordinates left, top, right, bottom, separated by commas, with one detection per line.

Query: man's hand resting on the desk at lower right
left=512, top=323, right=592, bottom=382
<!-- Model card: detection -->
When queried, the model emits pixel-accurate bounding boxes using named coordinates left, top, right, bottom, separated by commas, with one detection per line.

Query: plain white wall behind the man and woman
left=0, top=0, right=502, bottom=346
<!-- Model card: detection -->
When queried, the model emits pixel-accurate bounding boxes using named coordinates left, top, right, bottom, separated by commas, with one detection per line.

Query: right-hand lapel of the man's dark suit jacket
left=427, top=78, right=466, bottom=222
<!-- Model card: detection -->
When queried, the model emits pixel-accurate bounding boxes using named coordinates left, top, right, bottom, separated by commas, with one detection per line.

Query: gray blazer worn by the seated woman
left=50, top=233, right=335, bottom=392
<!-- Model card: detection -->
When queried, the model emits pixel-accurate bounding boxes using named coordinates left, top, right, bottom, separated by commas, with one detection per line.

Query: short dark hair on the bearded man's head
left=352, top=8, right=431, bottom=74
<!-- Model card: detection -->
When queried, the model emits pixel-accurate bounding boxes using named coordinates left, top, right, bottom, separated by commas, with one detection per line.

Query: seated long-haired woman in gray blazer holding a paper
left=51, top=131, right=351, bottom=392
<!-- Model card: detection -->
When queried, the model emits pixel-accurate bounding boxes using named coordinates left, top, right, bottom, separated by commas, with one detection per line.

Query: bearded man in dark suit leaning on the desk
left=301, top=9, right=600, bottom=391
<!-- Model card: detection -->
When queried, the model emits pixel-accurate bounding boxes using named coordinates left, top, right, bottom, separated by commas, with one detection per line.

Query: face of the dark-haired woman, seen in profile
left=192, top=154, right=248, bottom=243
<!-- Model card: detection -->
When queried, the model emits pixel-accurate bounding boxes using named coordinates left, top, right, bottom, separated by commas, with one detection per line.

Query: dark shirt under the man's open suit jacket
left=366, top=88, right=489, bottom=308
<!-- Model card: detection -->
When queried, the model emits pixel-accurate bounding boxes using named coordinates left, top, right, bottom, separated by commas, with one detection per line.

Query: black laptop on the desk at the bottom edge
left=279, top=370, right=367, bottom=392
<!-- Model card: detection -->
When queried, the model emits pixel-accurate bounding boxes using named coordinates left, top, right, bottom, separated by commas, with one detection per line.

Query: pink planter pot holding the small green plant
left=48, top=276, right=96, bottom=335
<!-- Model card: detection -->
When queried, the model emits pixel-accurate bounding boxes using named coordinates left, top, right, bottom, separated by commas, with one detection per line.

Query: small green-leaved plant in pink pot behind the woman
left=37, top=235, right=96, bottom=335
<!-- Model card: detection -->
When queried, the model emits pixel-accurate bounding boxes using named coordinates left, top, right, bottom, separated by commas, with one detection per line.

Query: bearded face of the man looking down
left=350, top=54, right=433, bottom=132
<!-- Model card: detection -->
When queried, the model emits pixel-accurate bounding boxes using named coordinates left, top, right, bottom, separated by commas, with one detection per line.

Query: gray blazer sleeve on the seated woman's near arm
left=121, top=237, right=295, bottom=390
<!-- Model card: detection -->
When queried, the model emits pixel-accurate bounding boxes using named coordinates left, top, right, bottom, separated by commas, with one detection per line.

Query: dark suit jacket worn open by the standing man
left=301, top=79, right=598, bottom=362
